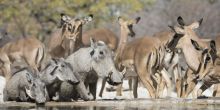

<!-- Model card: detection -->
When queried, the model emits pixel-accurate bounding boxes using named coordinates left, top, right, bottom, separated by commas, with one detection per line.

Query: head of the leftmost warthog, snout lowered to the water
left=25, top=72, right=48, bottom=104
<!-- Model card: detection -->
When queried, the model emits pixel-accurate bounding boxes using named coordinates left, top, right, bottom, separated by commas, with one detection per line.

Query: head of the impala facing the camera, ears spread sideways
left=60, top=14, right=93, bottom=40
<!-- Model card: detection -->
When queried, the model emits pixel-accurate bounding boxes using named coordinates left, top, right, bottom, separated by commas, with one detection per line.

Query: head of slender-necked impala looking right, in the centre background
left=118, top=17, right=141, bottom=37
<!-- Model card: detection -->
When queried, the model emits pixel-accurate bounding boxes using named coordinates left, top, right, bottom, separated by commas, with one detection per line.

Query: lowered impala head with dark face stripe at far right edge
left=191, top=39, right=217, bottom=80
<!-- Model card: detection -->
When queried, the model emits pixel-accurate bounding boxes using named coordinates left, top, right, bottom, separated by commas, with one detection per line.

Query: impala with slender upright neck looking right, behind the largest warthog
left=99, top=17, right=141, bottom=98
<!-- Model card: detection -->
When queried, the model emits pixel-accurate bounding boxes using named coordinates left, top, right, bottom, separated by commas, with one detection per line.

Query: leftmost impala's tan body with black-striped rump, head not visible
left=0, top=37, right=45, bottom=79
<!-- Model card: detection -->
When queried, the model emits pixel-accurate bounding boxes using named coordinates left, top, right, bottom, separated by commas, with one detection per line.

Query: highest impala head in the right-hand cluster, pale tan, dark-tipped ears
left=169, top=16, right=203, bottom=48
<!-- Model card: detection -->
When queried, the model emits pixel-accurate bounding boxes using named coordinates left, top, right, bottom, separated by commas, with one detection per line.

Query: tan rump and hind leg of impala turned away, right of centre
left=134, top=37, right=160, bottom=98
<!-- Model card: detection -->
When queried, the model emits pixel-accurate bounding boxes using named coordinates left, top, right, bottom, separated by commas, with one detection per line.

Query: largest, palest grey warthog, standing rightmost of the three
left=62, top=39, right=123, bottom=100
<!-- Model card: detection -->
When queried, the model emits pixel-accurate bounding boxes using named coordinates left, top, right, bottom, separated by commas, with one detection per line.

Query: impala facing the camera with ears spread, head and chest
left=48, top=14, right=93, bottom=58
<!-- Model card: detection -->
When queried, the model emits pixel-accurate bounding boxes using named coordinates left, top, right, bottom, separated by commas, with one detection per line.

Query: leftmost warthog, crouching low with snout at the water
left=3, top=68, right=48, bottom=104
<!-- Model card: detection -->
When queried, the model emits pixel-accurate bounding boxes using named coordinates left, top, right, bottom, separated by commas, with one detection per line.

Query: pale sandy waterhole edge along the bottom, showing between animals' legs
left=0, top=80, right=220, bottom=110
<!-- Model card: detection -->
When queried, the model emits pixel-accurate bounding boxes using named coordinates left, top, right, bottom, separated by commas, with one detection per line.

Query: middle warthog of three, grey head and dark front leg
left=40, top=58, right=79, bottom=100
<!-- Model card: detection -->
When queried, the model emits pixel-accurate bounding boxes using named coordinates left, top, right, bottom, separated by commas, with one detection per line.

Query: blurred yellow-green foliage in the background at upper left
left=0, top=0, right=154, bottom=39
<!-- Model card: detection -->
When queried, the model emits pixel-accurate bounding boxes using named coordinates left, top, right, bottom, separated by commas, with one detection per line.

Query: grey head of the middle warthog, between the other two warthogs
left=41, top=58, right=79, bottom=85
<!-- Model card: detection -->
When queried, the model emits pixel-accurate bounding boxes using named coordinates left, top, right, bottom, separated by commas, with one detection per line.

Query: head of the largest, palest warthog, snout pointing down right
left=90, top=38, right=125, bottom=85
